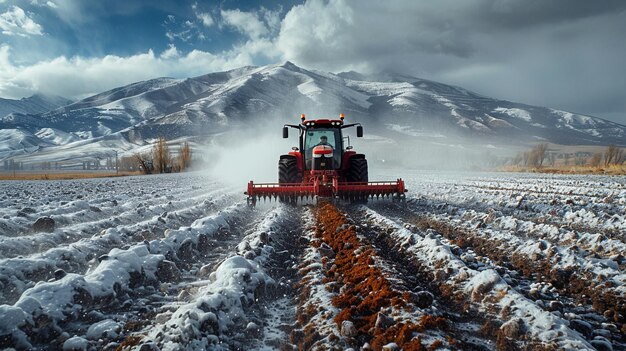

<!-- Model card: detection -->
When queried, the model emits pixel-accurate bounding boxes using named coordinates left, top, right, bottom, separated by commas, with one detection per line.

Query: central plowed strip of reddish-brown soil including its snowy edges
left=292, top=204, right=464, bottom=350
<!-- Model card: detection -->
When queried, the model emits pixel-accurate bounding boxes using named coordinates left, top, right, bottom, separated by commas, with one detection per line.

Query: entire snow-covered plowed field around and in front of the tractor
left=0, top=171, right=626, bottom=350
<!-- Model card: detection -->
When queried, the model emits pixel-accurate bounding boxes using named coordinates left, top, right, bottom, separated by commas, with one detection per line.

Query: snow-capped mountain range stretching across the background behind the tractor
left=0, top=62, right=626, bottom=162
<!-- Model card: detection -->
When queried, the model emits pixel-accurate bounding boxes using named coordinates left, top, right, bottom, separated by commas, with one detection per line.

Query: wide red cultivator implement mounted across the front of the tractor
left=245, top=178, right=406, bottom=204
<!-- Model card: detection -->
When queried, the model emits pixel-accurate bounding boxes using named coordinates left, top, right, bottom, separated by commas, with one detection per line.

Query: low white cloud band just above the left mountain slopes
left=0, top=45, right=256, bottom=98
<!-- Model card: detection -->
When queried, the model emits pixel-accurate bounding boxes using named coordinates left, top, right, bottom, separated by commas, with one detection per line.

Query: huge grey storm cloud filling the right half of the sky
left=278, top=0, right=626, bottom=123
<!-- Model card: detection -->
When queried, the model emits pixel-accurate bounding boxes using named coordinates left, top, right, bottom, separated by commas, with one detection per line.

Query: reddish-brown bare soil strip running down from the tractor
left=308, top=204, right=447, bottom=350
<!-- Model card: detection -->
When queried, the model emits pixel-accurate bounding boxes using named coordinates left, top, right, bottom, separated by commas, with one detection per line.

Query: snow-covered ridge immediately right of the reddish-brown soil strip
left=360, top=209, right=593, bottom=350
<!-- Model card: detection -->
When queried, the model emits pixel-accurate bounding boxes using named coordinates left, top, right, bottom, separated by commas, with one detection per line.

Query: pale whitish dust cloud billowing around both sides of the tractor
left=195, top=110, right=517, bottom=191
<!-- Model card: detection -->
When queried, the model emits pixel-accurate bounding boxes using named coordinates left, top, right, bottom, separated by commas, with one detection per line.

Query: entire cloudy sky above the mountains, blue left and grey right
left=0, top=0, right=626, bottom=124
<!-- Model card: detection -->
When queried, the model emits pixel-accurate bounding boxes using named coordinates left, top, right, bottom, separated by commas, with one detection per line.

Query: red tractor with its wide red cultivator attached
left=245, top=113, right=406, bottom=203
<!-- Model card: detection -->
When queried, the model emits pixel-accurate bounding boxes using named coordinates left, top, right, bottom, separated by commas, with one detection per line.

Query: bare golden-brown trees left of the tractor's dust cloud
left=132, top=137, right=191, bottom=174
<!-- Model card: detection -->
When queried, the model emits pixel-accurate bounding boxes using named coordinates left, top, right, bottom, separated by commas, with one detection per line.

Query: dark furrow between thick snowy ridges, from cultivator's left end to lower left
left=22, top=205, right=269, bottom=350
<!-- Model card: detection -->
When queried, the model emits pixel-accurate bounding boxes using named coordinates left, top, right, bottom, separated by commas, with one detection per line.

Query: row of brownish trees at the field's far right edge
left=511, top=143, right=626, bottom=168
